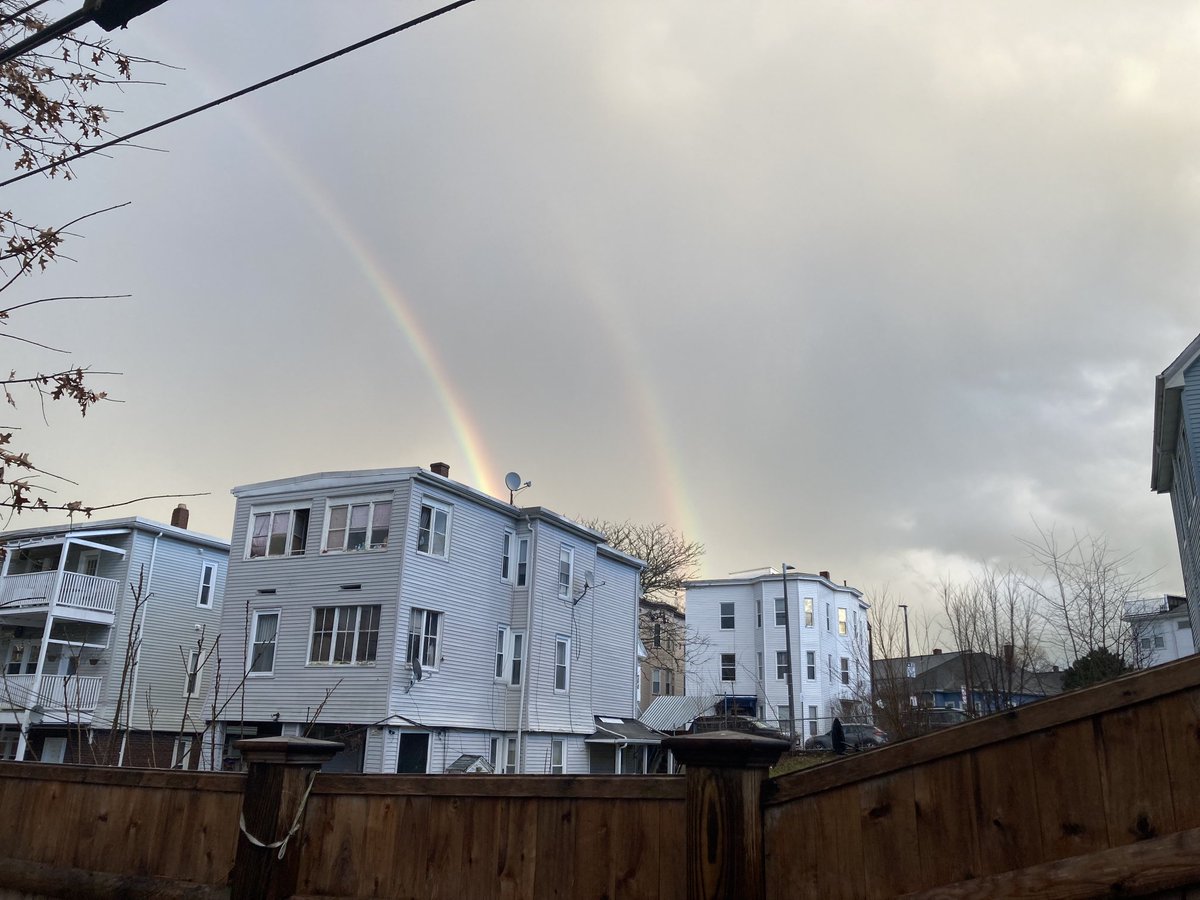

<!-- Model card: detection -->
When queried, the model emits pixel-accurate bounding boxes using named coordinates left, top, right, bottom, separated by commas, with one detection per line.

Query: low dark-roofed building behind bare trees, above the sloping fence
left=871, top=649, right=1064, bottom=715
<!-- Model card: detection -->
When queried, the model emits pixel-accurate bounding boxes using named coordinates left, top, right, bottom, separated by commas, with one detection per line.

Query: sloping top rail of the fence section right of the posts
left=766, top=655, right=1200, bottom=805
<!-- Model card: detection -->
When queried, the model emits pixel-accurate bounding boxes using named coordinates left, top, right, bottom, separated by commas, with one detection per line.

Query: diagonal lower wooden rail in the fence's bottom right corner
left=905, top=828, right=1200, bottom=900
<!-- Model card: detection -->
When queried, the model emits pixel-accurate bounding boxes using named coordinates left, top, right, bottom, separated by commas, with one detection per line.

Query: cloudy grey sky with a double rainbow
left=0, top=0, right=1200, bottom=633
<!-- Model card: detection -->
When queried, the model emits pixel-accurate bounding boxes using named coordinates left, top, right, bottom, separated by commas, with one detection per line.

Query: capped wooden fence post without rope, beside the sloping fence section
left=662, top=731, right=788, bottom=900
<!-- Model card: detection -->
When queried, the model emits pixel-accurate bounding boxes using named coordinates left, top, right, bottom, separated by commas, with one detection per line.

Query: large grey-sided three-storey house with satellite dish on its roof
left=215, top=463, right=658, bottom=774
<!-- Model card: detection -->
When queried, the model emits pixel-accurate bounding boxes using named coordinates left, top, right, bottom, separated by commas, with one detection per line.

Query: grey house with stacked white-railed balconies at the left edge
left=0, top=504, right=229, bottom=767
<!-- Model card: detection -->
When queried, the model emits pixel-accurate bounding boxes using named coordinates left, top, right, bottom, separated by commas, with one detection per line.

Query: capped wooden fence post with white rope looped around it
left=229, top=737, right=344, bottom=900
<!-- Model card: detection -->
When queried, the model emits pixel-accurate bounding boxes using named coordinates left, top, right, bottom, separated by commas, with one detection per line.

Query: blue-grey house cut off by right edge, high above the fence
left=1150, top=336, right=1200, bottom=634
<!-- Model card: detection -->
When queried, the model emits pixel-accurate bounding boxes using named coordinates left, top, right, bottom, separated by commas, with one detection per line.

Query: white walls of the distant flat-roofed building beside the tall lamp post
left=688, top=575, right=870, bottom=734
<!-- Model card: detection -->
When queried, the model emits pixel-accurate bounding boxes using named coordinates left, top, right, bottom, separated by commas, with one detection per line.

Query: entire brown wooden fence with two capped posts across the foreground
left=0, top=658, right=1200, bottom=900
